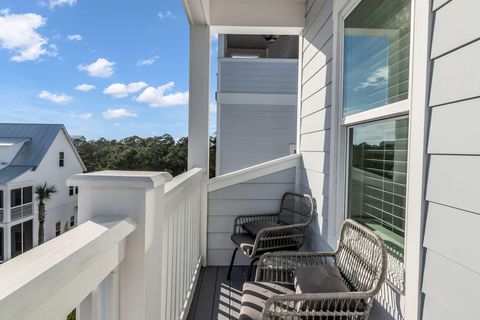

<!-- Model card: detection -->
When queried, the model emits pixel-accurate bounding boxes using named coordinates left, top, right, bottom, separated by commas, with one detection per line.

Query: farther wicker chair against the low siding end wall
left=227, top=192, right=316, bottom=280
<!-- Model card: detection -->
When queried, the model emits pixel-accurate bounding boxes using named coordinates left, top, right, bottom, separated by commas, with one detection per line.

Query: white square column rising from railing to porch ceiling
left=188, top=25, right=210, bottom=176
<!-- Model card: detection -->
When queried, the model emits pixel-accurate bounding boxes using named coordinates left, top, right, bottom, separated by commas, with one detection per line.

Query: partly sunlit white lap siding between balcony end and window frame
left=299, top=0, right=333, bottom=250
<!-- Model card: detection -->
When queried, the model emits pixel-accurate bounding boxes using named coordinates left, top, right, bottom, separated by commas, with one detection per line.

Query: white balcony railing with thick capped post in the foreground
left=0, top=169, right=206, bottom=320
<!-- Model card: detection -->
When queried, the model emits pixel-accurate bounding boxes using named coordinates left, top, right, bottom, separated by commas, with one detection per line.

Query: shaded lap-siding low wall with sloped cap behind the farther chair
left=207, top=168, right=295, bottom=265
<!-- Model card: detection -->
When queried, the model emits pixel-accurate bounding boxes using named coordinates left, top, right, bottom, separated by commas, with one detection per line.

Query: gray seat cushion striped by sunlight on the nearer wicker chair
left=238, top=282, right=295, bottom=320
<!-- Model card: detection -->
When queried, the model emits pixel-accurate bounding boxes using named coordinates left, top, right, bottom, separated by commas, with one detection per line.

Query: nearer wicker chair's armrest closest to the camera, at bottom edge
left=262, top=292, right=374, bottom=319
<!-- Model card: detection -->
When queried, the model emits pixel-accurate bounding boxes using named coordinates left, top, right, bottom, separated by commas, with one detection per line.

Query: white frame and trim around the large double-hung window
left=326, top=0, right=433, bottom=319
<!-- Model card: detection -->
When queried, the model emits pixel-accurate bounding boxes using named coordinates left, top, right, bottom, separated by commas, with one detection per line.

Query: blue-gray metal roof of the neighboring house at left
left=0, top=123, right=83, bottom=184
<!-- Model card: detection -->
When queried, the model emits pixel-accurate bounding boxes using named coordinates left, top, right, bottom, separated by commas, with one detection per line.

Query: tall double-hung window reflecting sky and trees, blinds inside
left=340, top=0, right=411, bottom=262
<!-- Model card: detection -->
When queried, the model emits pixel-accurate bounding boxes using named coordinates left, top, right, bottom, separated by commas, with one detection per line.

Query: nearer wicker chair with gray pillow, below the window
left=239, top=220, right=387, bottom=320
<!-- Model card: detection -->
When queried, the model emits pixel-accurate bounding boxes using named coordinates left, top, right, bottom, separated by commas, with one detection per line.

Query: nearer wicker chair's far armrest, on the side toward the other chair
left=255, top=251, right=335, bottom=283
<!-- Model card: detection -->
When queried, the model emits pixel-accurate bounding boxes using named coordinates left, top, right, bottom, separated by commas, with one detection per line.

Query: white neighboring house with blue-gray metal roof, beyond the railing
left=0, top=124, right=85, bottom=261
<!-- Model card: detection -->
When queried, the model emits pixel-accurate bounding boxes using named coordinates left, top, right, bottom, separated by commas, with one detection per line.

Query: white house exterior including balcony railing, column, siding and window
left=0, top=0, right=480, bottom=320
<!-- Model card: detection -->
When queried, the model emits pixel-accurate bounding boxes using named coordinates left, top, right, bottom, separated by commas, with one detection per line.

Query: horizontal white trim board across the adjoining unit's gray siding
left=217, top=92, right=297, bottom=106
